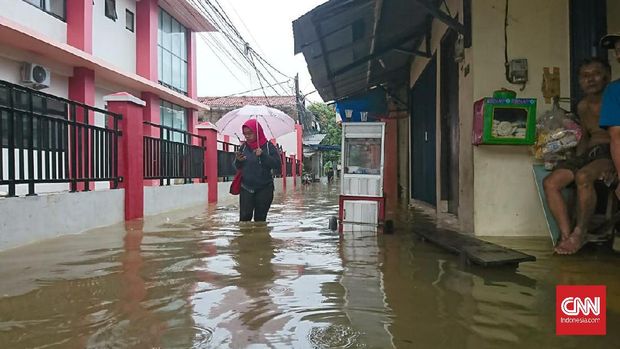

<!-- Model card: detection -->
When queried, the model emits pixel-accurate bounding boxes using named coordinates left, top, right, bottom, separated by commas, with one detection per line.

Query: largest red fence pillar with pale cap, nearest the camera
left=103, top=92, right=146, bottom=220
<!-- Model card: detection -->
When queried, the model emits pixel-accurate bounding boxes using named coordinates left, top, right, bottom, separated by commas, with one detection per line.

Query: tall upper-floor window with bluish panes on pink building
left=157, top=9, right=188, bottom=94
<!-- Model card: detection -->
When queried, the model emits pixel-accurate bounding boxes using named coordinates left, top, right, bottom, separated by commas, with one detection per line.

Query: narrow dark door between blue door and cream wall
left=440, top=30, right=459, bottom=214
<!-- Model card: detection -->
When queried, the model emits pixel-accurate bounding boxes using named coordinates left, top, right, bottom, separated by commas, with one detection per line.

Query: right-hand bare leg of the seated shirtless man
left=556, top=159, right=612, bottom=254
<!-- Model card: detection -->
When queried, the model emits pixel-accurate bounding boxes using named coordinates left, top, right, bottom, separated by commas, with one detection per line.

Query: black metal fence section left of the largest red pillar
left=0, top=80, right=121, bottom=197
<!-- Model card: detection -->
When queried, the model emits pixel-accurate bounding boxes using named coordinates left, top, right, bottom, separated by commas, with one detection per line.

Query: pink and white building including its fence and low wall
left=0, top=0, right=301, bottom=251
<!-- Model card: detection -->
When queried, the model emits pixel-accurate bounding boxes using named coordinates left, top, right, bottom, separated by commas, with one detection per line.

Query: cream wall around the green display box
left=468, top=0, right=570, bottom=236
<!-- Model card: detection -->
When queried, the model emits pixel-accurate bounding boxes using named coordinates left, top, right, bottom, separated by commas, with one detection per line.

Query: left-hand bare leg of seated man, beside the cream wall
left=543, top=169, right=575, bottom=245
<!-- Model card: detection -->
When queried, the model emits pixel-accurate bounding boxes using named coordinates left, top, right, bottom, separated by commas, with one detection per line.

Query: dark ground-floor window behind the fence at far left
left=0, top=87, right=68, bottom=151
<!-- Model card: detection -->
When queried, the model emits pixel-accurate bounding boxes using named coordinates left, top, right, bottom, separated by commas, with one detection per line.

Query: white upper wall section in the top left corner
left=0, top=0, right=67, bottom=43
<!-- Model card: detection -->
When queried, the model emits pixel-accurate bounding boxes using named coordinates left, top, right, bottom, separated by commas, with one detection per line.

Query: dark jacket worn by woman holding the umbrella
left=235, top=142, right=282, bottom=191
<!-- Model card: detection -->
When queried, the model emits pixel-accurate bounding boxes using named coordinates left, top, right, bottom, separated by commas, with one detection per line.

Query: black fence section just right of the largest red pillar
left=144, top=121, right=205, bottom=185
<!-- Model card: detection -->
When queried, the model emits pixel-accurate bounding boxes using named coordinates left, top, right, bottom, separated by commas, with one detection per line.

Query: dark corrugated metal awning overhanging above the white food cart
left=293, top=0, right=463, bottom=101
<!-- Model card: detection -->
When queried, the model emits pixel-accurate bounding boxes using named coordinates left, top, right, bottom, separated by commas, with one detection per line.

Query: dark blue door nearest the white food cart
left=409, top=57, right=437, bottom=206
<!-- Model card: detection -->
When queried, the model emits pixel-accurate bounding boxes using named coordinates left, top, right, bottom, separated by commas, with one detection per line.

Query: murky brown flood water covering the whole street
left=0, top=184, right=620, bottom=349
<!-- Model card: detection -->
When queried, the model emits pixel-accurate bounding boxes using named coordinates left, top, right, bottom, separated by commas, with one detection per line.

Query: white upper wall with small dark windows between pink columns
left=93, top=0, right=136, bottom=73
